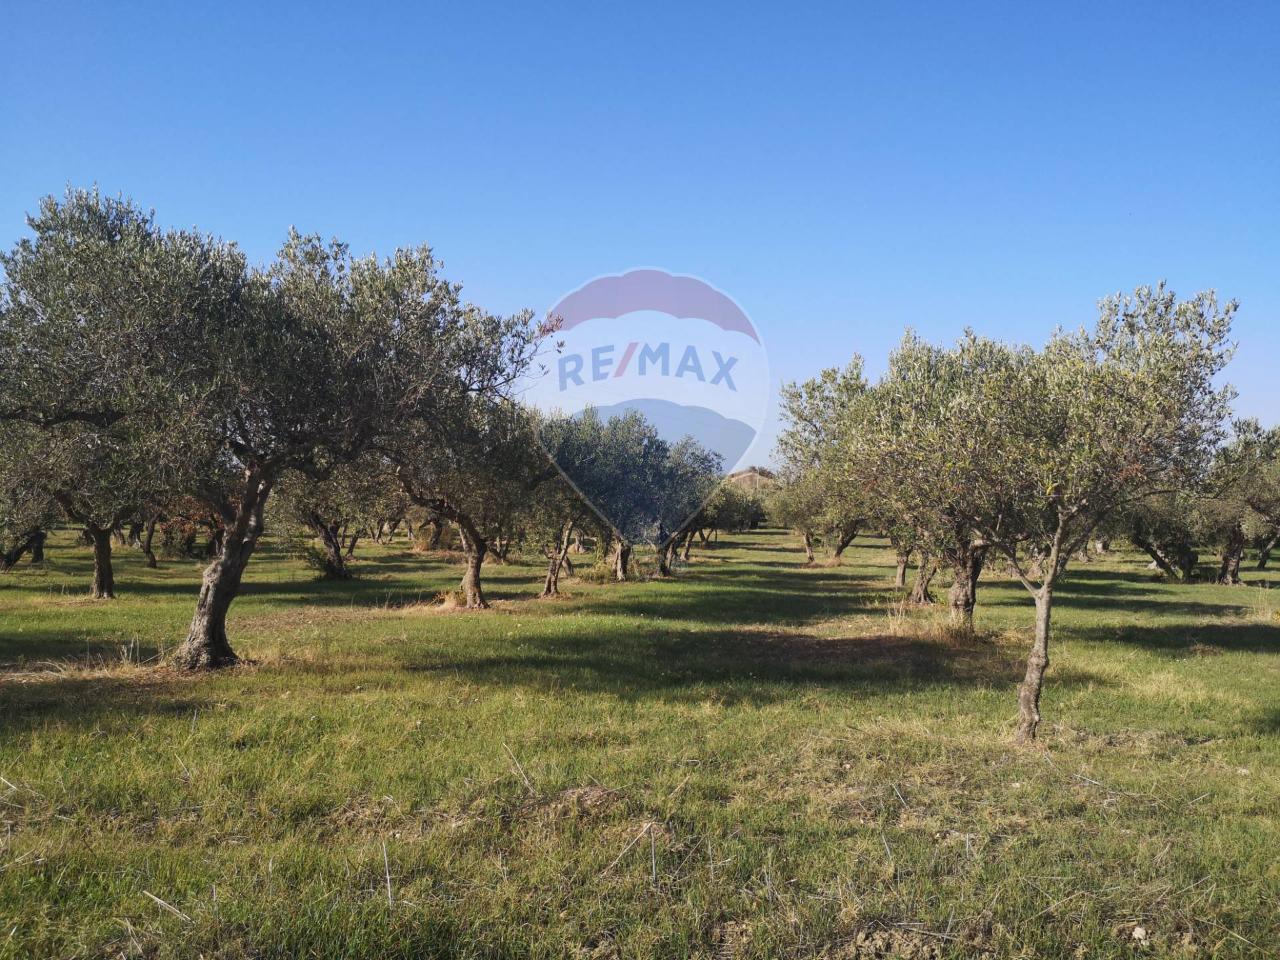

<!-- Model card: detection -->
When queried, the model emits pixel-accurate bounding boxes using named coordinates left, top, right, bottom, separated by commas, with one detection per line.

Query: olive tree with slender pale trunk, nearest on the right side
left=947, top=284, right=1235, bottom=741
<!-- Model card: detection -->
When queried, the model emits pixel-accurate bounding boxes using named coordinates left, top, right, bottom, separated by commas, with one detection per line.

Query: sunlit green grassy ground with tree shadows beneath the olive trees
left=0, top=531, right=1280, bottom=960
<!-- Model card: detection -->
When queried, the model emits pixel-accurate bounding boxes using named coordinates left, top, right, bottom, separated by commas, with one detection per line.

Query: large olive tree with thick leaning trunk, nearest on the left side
left=174, top=233, right=536, bottom=668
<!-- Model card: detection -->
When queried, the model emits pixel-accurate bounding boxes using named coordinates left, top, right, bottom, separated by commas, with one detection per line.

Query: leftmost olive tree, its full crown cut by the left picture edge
left=0, top=189, right=243, bottom=598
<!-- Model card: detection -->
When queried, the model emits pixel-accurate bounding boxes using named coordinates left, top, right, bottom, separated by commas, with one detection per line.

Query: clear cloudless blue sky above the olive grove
left=0, top=3, right=1280, bottom=463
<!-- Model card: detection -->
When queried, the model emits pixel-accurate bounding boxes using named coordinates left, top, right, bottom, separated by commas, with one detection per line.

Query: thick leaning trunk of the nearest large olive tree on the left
left=173, top=470, right=273, bottom=669
